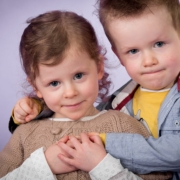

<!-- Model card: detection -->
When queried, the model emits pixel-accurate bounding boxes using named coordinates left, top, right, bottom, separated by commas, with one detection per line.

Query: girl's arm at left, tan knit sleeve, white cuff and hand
left=0, top=125, right=76, bottom=180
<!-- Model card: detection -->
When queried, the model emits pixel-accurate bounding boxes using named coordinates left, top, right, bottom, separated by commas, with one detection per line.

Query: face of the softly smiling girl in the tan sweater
left=35, top=49, right=103, bottom=120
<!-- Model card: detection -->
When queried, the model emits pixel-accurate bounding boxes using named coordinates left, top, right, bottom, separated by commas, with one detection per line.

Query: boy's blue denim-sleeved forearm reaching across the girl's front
left=106, top=133, right=180, bottom=174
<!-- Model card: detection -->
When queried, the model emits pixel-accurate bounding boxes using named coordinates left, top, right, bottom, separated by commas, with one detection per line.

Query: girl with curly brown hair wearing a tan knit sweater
left=0, top=11, right=167, bottom=180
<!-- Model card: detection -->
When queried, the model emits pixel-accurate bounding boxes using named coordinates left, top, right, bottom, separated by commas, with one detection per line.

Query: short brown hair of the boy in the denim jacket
left=98, top=0, right=180, bottom=44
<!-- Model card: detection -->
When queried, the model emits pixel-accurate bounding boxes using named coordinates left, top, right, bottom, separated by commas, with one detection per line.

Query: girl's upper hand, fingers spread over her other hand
left=58, top=133, right=106, bottom=172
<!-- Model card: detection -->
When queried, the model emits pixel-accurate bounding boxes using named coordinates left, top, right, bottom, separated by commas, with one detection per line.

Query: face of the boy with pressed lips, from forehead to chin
left=108, top=7, right=180, bottom=90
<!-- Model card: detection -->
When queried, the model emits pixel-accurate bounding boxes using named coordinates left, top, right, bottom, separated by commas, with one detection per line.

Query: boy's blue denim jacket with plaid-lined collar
left=98, top=80, right=180, bottom=180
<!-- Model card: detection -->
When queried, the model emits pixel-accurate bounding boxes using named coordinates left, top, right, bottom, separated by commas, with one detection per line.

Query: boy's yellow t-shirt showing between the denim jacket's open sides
left=133, top=87, right=170, bottom=138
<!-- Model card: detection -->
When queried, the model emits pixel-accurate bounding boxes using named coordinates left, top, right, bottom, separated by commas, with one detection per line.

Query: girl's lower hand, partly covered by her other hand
left=45, top=137, right=77, bottom=174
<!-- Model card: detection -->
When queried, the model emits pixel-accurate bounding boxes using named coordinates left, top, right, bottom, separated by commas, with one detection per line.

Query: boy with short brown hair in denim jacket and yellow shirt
left=9, top=0, right=180, bottom=180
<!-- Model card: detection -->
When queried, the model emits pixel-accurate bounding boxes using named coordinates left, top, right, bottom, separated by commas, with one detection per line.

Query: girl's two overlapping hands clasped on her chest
left=45, top=133, right=106, bottom=174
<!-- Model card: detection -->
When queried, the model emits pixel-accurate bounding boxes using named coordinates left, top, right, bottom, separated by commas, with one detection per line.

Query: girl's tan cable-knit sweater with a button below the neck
left=0, top=110, right=172, bottom=180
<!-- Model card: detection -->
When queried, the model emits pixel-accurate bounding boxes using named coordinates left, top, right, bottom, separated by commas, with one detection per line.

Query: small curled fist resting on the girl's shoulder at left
left=13, top=97, right=39, bottom=124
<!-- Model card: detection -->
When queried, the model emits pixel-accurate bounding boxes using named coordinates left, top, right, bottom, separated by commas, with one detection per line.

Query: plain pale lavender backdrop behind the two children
left=0, top=0, right=129, bottom=151
